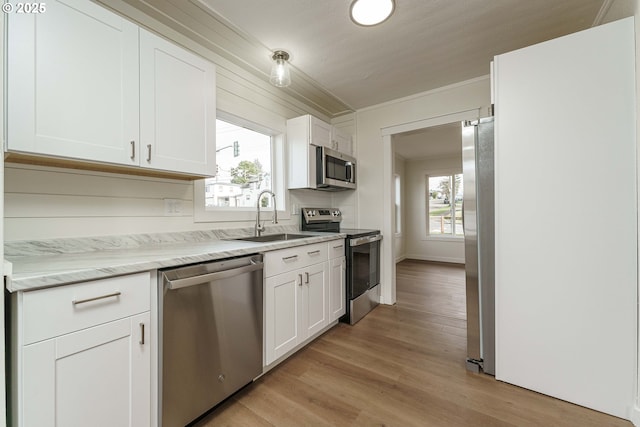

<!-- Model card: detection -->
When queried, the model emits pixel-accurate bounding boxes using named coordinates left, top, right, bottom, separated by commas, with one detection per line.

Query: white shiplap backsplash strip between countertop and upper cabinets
left=4, top=163, right=344, bottom=241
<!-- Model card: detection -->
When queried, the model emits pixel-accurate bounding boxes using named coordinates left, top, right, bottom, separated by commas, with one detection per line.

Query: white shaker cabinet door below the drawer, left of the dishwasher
left=20, top=312, right=151, bottom=427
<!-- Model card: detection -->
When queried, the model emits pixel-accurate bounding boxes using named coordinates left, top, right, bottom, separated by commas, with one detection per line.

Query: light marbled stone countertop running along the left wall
left=5, top=226, right=346, bottom=292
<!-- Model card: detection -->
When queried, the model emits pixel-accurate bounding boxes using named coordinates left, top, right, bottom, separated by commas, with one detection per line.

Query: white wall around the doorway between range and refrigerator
left=356, top=77, right=491, bottom=304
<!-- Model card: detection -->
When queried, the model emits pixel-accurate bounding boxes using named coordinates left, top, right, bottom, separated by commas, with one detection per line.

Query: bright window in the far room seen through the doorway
left=427, top=174, right=464, bottom=236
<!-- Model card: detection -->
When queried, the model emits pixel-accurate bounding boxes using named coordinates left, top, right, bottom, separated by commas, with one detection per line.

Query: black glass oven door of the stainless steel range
left=347, top=234, right=382, bottom=300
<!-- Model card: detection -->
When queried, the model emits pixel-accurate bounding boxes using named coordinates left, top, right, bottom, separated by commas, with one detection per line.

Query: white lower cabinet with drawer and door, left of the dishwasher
left=11, top=273, right=152, bottom=427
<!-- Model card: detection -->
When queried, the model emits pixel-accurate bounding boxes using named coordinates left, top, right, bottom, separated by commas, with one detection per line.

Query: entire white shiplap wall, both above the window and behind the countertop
left=4, top=0, right=357, bottom=241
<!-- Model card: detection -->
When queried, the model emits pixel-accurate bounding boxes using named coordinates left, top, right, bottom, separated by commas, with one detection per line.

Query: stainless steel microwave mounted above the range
left=316, top=147, right=356, bottom=191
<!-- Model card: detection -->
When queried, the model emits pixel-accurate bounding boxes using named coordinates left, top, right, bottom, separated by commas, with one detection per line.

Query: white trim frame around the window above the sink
left=193, top=111, right=290, bottom=223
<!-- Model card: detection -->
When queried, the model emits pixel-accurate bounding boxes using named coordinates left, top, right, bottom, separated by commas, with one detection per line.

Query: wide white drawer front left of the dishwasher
left=22, top=272, right=151, bottom=345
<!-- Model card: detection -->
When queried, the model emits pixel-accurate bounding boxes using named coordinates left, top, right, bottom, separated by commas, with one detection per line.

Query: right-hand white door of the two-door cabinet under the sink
left=300, top=262, right=329, bottom=339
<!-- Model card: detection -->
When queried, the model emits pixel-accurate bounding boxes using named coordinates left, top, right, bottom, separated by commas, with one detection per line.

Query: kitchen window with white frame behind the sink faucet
left=194, top=112, right=286, bottom=222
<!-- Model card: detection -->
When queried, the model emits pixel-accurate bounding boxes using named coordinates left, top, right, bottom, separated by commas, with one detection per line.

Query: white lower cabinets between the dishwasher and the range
left=265, top=241, right=345, bottom=366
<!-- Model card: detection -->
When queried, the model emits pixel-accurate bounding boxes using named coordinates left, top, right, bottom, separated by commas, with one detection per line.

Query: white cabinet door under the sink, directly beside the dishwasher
left=264, top=270, right=304, bottom=365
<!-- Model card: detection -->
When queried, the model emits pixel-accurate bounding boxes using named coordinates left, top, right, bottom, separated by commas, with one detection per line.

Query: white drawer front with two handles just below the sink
left=264, top=243, right=329, bottom=277
